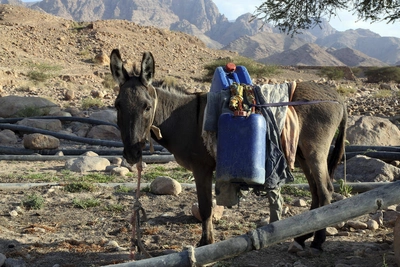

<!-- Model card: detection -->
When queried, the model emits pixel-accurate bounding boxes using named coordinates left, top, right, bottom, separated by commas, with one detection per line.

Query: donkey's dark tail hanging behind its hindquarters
left=328, top=105, right=347, bottom=178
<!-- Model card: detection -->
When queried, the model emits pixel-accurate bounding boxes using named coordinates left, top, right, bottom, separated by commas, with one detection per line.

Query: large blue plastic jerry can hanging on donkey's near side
left=216, top=113, right=267, bottom=185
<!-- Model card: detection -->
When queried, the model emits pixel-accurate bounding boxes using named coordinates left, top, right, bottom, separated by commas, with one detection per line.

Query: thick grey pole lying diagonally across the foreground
left=104, top=181, right=400, bottom=267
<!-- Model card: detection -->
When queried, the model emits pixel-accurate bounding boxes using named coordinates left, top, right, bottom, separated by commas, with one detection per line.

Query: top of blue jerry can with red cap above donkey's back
left=210, top=63, right=252, bottom=92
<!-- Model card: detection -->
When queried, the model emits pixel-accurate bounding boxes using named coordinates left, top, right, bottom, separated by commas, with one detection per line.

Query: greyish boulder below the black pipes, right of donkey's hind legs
left=334, top=155, right=400, bottom=182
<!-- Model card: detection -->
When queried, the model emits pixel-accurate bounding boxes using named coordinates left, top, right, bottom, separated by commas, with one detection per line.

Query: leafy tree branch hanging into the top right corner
left=252, top=0, right=400, bottom=36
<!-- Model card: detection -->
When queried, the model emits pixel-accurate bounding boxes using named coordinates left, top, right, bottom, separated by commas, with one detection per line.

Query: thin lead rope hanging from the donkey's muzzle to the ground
left=130, top=160, right=151, bottom=260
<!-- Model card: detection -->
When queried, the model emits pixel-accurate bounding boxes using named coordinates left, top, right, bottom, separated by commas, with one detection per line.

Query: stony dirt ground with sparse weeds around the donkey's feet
left=0, top=161, right=397, bottom=267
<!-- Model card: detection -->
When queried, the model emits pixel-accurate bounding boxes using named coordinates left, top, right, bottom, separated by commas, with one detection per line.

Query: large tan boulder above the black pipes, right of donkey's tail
left=346, top=116, right=400, bottom=146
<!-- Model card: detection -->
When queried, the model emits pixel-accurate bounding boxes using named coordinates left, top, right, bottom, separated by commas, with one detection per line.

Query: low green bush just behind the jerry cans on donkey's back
left=204, top=57, right=279, bottom=80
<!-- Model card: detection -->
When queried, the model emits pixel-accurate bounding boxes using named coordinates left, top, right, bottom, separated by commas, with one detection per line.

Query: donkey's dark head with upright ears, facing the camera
left=110, top=49, right=157, bottom=164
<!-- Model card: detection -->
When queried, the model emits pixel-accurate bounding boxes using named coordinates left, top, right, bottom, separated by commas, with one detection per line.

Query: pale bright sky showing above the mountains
left=23, top=0, right=400, bottom=38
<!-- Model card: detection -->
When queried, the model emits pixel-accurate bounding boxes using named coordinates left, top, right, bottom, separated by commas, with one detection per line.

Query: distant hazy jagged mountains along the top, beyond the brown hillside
left=6, top=0, right=400, bottom=66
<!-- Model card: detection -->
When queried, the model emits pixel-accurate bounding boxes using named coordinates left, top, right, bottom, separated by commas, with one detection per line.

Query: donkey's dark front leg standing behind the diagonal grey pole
left=193, top=169, right=214, bottom=246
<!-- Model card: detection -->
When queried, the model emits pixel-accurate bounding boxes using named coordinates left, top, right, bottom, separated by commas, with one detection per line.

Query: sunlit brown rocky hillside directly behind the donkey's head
left=0, top=4, right=237, bottom=105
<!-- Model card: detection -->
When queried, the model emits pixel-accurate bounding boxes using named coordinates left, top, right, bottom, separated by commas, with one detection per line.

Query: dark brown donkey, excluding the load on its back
left=110, top=49, right=347, bottom=251
